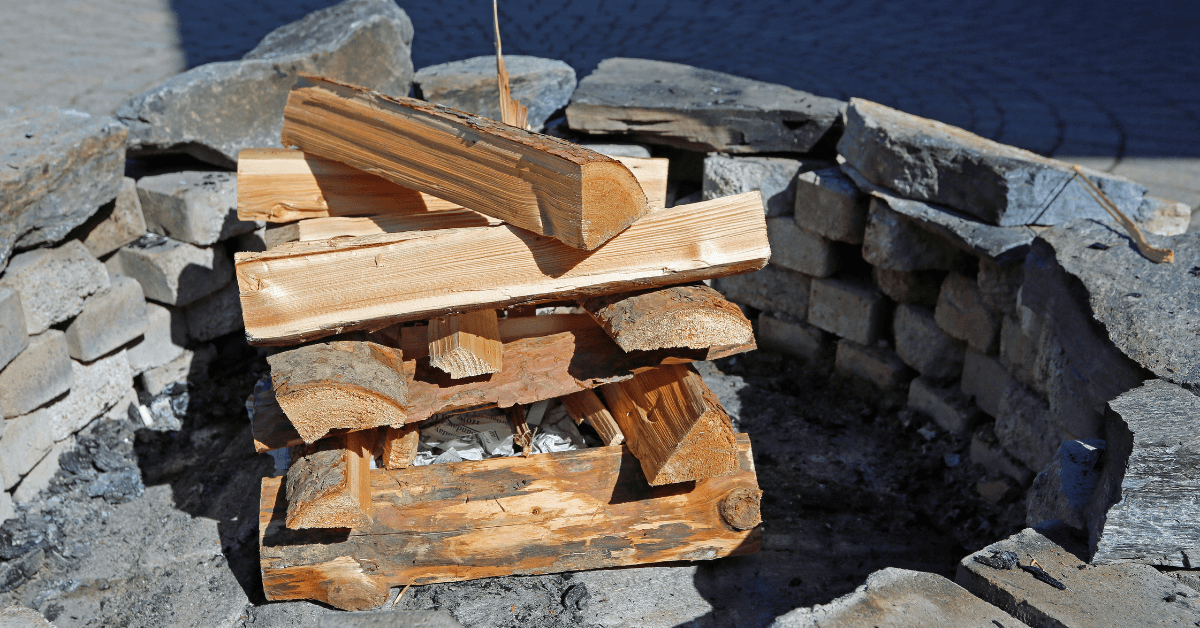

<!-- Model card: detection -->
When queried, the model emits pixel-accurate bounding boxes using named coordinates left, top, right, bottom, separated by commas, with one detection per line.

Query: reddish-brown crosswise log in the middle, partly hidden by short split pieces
left=252, top=315, right=754, bottom=451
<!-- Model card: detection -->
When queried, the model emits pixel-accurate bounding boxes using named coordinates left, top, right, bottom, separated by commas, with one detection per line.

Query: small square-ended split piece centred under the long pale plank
left=428, top=310, right=504, bottom=379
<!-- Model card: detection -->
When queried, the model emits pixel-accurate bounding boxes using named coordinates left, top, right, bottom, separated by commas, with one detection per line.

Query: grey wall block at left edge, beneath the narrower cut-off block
left=0, top=329, right=73, bottom=417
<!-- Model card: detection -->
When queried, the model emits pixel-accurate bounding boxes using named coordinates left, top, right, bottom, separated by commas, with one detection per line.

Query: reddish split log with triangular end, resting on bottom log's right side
left=600, top=365, right=737, bottom=486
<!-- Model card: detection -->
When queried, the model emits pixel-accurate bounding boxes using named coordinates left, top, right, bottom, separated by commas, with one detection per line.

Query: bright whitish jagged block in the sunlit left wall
left=46, top=349, right=133, bottom=442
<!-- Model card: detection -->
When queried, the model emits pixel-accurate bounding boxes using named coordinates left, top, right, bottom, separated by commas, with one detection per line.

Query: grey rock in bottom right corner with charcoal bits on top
left=954, top=527, right=1200, bottom=628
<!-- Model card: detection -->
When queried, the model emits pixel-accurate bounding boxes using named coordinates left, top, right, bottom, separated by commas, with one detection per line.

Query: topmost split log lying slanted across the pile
left=282, top=74, right=649, bottom=251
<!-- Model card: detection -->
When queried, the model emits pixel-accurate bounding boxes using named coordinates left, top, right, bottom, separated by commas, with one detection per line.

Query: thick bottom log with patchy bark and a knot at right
left=259, top=435, right=762, bottom=610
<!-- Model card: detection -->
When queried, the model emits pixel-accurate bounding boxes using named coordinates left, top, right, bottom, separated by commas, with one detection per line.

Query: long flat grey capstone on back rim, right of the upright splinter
left=566, top=58, right=845, bottom=154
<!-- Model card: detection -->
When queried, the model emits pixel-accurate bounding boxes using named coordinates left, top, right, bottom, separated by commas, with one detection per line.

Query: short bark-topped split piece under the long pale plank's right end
left=580, top=283, right=754, bottom=351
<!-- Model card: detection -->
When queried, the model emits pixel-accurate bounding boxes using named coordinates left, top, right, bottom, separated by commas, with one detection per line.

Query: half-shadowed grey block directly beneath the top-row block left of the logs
left=116, top=235, right=233, bottom=305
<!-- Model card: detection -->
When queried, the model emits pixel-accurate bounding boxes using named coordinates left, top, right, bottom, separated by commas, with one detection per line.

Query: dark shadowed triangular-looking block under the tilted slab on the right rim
left=863, top=197, right=966, bottom=271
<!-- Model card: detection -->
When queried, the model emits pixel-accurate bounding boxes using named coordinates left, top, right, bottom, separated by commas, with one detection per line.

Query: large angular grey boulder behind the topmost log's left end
left=116, top=0, right=413, bottom=167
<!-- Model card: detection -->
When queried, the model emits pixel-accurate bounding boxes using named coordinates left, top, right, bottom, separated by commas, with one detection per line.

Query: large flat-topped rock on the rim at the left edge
left=0, top=107, right=126, bottom=269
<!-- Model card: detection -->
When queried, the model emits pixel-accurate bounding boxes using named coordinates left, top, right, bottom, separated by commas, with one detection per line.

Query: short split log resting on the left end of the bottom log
left=286, top=430, right=377, bottom=530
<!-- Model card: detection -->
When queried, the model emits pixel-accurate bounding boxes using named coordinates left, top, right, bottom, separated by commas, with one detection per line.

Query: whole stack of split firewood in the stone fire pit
left=236, top=77, right=770, bottom=609
